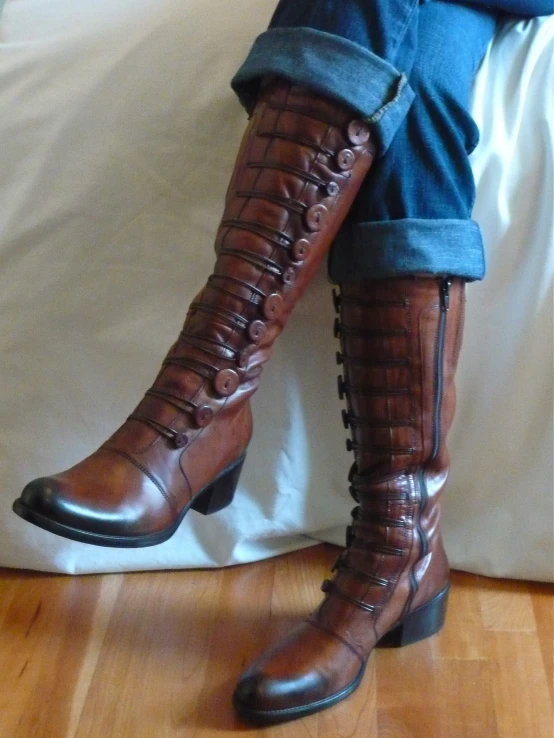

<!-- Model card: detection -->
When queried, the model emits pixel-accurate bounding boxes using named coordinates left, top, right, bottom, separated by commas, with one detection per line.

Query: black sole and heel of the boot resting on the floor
left=233, top=585, right=450, bottom=725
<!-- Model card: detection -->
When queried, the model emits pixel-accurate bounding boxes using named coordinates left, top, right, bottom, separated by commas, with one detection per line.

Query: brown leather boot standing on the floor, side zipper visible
left=234, top=278, right=464, bottom=724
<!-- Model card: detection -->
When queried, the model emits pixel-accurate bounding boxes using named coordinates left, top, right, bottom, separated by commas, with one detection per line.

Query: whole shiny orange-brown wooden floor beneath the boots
left=0, top=546, right=554, bottom=738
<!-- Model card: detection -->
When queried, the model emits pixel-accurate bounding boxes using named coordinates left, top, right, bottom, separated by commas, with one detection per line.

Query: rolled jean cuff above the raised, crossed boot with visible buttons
left=231, top=27, right=414, bottom=154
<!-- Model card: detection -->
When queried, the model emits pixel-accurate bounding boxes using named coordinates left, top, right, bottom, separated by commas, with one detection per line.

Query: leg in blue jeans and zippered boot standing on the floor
left=234, top=2, right=495, bottom=723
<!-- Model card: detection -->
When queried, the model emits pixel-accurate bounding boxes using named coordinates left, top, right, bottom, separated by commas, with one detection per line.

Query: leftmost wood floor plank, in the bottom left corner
left=0, top=575, right=100, bottom=738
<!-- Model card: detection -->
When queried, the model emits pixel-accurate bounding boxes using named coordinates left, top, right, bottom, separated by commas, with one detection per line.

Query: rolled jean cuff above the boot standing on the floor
left=328, top=218, right=485, bottom=283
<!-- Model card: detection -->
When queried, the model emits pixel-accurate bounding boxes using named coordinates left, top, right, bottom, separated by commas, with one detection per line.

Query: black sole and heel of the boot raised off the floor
left=12, top=456, right=245, bottom=548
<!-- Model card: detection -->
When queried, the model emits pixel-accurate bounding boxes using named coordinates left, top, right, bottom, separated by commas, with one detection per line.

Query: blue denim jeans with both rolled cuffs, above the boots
left=227, top=0, right=516, bottom=282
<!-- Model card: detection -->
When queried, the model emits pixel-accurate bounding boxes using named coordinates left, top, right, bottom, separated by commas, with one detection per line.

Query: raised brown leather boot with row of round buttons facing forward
left=14, top=79, right=374, bottom=546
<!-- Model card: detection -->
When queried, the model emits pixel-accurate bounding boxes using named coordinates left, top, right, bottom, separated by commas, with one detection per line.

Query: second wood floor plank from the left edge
left=76, top=571, right=223, bottom=738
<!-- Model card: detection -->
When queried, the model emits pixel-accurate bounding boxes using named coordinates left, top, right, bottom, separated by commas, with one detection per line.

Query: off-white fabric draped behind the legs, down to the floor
left=0, top=0, right=554, bottom=580
